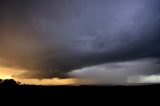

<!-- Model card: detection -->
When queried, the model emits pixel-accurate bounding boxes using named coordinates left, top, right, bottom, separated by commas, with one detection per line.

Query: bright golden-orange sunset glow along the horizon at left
left=0, top=66, right=95, bottom=85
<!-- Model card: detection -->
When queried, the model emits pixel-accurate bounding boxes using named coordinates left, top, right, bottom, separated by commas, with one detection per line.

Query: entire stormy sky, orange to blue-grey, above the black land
left=0, top=0, right=160, bottom=85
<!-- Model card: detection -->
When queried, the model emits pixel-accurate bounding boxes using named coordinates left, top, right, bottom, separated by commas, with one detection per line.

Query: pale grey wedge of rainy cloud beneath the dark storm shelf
left=70, top=59, right=160, bottom=84
